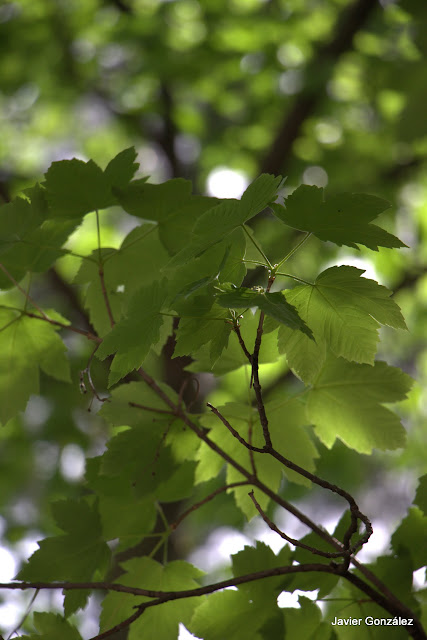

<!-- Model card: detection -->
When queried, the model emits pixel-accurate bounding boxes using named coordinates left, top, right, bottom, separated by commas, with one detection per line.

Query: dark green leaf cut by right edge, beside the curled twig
left=391, top=507, right=427, bottom=571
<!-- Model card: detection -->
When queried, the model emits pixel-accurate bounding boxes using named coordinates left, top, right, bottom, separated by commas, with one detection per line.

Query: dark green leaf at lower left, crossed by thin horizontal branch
left=17, top=499, right=111, bottom=615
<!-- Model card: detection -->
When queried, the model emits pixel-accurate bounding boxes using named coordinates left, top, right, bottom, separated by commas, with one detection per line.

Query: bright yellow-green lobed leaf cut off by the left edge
left=0, top=308, right=70, bottom=424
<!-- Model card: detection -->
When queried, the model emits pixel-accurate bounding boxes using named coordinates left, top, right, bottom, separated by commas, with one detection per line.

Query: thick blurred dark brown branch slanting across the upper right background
left=260, top=0, right=378, bottom=174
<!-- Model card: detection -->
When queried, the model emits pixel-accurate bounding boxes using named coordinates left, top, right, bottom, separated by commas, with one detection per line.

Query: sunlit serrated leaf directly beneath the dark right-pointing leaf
left=279, top=266, right=406, bottom=382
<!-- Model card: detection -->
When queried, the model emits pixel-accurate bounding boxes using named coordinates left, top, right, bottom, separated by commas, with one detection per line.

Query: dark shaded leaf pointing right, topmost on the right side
left=272, top=185, right=406, bottom=251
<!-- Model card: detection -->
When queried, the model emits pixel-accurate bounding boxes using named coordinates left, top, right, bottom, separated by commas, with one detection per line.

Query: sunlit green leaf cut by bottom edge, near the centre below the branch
left=191, top=591, right=266, bottom=640
